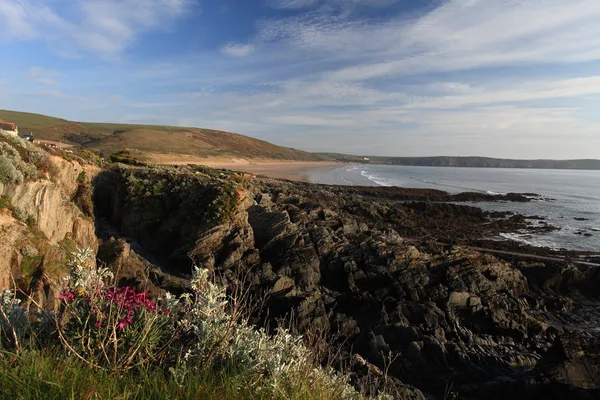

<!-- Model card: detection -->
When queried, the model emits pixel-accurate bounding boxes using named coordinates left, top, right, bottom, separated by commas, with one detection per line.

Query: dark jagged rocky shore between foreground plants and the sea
left=88, top=163, right=600, bottom=399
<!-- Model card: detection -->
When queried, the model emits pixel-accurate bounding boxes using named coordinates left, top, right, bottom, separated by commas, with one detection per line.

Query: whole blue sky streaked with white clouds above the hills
left=0, top=0, right=600, bottom=159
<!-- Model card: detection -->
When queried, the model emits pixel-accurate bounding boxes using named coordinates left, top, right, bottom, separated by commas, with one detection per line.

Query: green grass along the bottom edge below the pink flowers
left=0, top=349, right=278, bottom=400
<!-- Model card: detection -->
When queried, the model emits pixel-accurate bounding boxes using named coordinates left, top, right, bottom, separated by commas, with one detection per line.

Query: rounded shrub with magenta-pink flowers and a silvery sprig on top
left=59, top=250, right=171, bottom=370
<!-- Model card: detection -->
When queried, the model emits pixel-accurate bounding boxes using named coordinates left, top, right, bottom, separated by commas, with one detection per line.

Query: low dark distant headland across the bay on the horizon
left=320, top=153, right=600, bottom=170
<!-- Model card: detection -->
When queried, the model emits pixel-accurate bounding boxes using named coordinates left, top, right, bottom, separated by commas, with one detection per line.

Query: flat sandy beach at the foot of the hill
left=147, top=154, right=342, bottom=182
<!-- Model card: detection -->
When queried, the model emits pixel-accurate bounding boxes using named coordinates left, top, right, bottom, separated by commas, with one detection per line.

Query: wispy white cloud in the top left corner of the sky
left=0, top=0, right=193, bottom=57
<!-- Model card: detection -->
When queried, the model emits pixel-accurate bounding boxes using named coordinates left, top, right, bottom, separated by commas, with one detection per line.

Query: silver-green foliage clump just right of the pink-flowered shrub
left=180, top=268, right=360, bottom=399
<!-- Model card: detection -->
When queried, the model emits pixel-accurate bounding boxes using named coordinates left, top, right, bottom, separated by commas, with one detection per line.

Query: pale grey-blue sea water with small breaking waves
left=310, top=165, right=600, bottom=252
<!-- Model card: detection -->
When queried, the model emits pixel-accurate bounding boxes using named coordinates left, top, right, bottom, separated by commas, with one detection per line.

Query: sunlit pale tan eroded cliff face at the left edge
left=0, top=157, right=99, bottom=305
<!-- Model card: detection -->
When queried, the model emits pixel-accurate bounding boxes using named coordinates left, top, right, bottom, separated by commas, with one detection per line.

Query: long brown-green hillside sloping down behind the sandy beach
left=0, top=110, right=321, bottom=161
